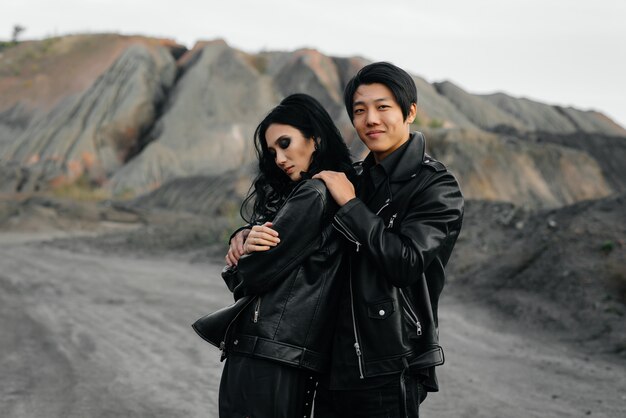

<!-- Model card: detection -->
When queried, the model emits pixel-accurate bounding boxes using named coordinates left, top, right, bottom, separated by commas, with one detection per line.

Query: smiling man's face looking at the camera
left=352, top=83, right=417, bottom=162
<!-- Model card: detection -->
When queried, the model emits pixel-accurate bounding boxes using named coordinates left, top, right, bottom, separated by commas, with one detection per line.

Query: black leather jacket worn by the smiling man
left=333, top=132, right=463, bottom=390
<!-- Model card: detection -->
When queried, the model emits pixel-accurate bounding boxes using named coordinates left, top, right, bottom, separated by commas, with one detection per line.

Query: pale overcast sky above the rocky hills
left=0, top=0, right=626, bottom=126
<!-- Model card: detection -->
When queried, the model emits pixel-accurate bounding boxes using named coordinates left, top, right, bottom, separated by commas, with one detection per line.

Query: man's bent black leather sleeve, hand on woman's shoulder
left=333, top=172, right=463, bottom=287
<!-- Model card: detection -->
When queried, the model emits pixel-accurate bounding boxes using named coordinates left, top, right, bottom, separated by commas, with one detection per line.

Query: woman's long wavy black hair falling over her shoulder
left=240, top=93, right=354, bottom=224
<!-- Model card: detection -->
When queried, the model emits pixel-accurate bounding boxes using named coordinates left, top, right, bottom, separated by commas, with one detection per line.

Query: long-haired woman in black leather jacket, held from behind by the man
left=193, top=94, right=353, bottom=418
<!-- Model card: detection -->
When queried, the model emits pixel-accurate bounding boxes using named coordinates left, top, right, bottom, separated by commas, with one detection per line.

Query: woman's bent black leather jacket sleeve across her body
left=225, top=180, right=328, bottom=299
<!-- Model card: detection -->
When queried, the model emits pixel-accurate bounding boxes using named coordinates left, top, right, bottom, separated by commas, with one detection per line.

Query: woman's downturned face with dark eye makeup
left=265, top=123, right=315, bottom=181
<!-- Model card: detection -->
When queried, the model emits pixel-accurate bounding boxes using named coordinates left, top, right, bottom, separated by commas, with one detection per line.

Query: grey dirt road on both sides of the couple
left=0, top=236, right=626, bottom=418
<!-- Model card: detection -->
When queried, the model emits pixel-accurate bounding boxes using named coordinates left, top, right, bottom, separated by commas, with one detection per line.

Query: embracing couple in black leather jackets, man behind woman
left=194, top=62, right=463, bottom=418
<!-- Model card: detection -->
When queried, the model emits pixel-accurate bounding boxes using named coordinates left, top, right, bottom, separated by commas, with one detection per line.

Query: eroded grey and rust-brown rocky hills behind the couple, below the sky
left=0, top=35, right=626, bottom=208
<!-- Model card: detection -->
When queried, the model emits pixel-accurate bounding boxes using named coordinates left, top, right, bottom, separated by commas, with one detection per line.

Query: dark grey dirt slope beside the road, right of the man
left=449, top=194, right=626, bottom=358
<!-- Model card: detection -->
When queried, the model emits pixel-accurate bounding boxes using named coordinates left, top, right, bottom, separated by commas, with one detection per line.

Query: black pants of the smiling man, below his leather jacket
left=313, top=376, right=426, bottom=418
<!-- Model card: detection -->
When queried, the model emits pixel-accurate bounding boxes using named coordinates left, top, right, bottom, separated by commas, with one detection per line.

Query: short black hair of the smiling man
left=343, top=62, right=417, bottom=120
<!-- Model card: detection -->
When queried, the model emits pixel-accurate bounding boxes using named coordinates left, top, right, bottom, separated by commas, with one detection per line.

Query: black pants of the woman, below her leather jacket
left=219, top=354, right=317, bottom=418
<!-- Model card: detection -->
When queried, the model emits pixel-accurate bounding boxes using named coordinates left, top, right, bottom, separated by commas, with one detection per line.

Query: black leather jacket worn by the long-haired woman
left=222, top=180, right=346, bottom=371
